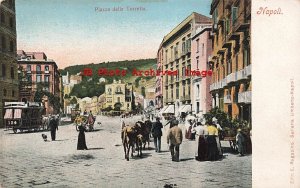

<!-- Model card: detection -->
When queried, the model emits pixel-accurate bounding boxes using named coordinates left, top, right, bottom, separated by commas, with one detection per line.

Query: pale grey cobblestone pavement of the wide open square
left=0, top=116, right=252, bottom=188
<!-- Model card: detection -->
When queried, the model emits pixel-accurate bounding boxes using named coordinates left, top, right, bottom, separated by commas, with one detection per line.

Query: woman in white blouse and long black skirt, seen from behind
left=194, top=122, right=208, bottom=161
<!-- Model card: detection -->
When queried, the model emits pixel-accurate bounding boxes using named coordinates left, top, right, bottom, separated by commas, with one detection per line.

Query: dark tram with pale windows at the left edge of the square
left=4, top=102, right=47, bottom=133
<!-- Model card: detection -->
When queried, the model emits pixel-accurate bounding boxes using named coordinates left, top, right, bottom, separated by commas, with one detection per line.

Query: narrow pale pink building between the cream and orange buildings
left=191, top=24, right=212, bottom=116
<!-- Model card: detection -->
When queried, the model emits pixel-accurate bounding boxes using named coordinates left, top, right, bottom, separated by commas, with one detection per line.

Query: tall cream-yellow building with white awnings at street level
left=162, top=12, right=211, bottom=115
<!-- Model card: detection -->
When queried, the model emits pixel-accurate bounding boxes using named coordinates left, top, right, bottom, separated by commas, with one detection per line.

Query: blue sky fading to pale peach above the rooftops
left=16, top=0, right=211, bottom=68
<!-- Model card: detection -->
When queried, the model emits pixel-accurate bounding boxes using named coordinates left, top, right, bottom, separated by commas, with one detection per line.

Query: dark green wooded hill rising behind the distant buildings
left=60, top=59, right=156, bottom=98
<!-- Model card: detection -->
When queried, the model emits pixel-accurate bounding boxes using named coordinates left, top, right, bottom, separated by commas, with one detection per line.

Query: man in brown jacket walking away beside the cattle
left=167, top=120, right=182, bottom=162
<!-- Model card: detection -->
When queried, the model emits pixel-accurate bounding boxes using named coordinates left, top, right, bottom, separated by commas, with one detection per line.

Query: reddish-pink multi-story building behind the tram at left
left=17, top=50, right=61, bottom=114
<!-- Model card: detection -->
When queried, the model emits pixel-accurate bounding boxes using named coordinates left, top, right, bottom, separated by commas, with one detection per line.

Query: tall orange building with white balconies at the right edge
left=209, top=0, right=251, bottom=122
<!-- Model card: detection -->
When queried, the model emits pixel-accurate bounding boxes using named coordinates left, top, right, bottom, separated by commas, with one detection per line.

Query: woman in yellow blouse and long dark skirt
left=207, top=122, right=218, bottom=161
